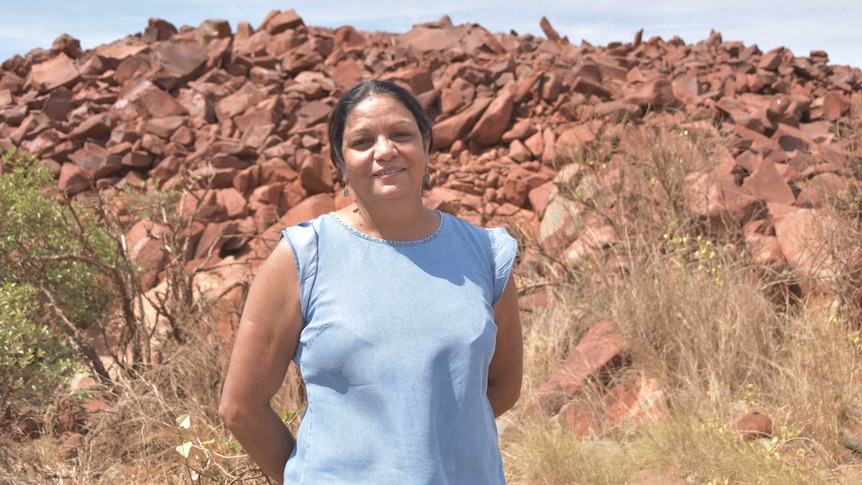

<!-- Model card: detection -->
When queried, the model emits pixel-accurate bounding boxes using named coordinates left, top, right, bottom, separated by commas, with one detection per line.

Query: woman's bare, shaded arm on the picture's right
left=488, top=276, right=524, bottom=417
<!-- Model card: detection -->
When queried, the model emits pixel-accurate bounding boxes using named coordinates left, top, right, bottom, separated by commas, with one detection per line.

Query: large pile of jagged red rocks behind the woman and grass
left=0, top=10, right=862, bottom=440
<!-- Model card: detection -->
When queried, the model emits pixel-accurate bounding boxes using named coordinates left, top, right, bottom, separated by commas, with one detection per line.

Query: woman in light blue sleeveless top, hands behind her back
left=219, top=81, right=523, bottom=485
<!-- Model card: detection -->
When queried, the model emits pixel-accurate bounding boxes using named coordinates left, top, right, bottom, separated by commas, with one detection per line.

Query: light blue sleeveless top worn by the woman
left=282, top=212, right=517, bottom=485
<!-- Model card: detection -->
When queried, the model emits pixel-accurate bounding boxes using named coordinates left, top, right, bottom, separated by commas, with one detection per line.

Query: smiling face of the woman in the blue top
left=342, top=94, right=429, bottom=202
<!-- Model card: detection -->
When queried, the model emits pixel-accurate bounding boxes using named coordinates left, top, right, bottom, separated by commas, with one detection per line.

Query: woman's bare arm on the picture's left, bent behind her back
left=219, top=240, right=303, bottom=483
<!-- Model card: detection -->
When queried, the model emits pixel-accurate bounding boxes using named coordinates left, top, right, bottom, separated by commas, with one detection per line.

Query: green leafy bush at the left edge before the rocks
left=0, top=151, right=111, bottom=406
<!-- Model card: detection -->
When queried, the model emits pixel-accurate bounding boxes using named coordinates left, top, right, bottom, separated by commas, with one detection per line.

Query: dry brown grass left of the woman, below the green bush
left=0, top=302, right=304, bottom=484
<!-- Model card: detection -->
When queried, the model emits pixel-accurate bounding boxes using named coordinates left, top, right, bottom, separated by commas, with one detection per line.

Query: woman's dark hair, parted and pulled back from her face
left=329, top=80, right=434, bottom=177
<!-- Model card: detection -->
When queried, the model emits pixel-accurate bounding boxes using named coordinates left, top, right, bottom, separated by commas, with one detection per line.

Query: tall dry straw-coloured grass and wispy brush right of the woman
left=505, top=119, right=862, bottom=484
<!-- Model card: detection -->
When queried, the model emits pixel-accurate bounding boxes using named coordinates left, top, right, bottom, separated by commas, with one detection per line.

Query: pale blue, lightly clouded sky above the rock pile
left=0, top=0, right=862, bottom=67
